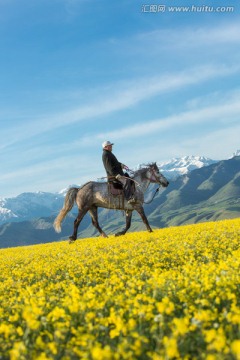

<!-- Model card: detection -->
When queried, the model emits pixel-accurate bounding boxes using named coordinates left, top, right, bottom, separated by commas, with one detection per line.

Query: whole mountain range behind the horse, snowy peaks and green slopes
left=0, top=152, right=240, bottom=248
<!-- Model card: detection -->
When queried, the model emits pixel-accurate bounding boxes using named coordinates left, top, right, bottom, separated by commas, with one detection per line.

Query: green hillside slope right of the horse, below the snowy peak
left=147, top=156, right=240, bottom=226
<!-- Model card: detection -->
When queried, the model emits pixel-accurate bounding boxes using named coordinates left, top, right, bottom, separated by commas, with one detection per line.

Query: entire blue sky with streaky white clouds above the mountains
left=0, top=0, right=240, bottom=197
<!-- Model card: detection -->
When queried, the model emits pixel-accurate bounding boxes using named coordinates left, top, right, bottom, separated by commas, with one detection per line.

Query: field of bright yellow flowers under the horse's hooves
left=0, top=219, right=240, bottom=360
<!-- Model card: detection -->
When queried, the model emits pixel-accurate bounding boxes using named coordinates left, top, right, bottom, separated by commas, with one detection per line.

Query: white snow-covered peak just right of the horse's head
left=157, top=156, right=218, bottom=180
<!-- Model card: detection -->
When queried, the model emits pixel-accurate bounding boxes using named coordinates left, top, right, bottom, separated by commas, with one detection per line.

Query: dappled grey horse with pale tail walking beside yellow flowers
left=53, top=163, right=169, bottom=242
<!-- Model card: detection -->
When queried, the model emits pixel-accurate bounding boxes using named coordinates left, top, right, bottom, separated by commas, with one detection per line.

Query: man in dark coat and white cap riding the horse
left=102, top=141, right=135, bottom=204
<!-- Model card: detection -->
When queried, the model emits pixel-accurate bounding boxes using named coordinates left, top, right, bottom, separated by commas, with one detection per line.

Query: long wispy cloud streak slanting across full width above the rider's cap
left=1, top=65, right=240, bottom=148
